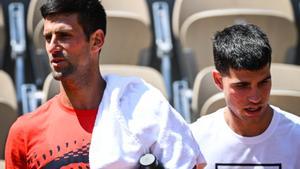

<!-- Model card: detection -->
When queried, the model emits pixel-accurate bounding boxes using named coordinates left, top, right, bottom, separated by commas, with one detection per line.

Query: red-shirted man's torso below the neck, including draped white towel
left=6, top=75, right=204, bottom=169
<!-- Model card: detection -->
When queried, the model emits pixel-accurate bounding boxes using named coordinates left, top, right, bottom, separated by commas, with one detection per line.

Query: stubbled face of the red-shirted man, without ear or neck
left=43, top=14, right=91, bottom=80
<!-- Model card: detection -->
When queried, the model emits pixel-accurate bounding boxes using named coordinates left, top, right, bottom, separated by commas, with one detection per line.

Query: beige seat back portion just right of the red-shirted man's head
left=96, top=0, right=152, bottom=65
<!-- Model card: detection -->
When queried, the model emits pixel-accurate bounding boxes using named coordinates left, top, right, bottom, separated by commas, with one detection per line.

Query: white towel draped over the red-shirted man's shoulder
left=89, top=75, right=204, bottom=169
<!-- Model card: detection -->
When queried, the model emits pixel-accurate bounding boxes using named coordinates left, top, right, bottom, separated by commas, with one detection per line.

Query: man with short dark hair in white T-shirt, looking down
left=190, top=24, right=300, bottom=169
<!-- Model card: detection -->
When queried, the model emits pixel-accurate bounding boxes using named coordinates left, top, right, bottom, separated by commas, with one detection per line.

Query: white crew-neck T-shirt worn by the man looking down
left=190, top=106, right=300, bottom=169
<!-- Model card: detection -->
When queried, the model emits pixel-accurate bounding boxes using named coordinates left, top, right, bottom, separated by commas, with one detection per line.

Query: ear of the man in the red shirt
left=90, top=29, right=104, bottom=53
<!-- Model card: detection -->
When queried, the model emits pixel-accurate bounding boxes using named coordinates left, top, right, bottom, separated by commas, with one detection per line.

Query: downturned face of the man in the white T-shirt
left=213, top=65, right=271, bottom=124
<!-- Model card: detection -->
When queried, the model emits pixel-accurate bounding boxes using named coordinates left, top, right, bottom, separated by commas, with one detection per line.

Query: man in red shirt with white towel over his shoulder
left=5, top=0, right=204, bottom=169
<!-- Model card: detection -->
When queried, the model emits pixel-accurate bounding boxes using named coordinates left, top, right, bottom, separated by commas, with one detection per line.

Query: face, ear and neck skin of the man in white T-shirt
left=213, top=65, right=273, bottom=137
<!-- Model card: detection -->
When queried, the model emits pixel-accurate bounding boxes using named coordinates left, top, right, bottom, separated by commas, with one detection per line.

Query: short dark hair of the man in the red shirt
left=40, top=0, right=106, bottom=39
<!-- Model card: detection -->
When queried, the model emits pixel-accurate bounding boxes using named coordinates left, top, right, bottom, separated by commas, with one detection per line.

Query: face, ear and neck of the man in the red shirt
left=43, top=14, right=105, bottom=110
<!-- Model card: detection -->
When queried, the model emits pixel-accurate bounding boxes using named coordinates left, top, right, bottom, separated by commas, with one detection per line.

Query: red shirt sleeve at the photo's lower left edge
left=5, top=118, right=27, bottom=169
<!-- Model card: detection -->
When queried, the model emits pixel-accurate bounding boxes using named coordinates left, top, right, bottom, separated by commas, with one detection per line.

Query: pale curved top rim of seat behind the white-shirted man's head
left=173, top=0, right=294, bottom=35
